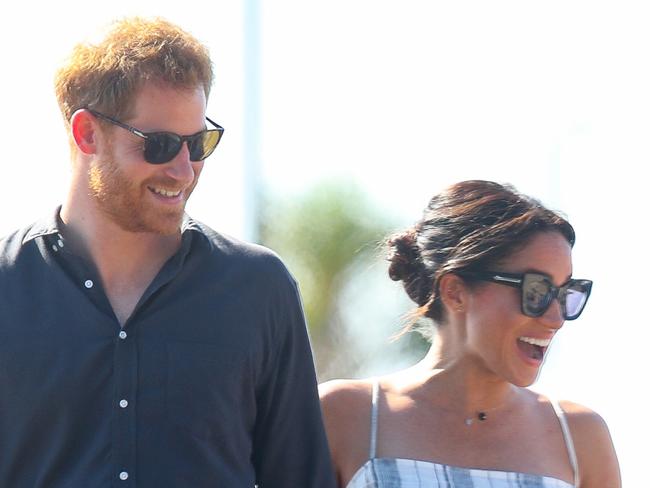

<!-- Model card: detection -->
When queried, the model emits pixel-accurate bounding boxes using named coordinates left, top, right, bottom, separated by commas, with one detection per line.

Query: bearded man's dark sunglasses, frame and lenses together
left=87, top=109, right=223, bottom=164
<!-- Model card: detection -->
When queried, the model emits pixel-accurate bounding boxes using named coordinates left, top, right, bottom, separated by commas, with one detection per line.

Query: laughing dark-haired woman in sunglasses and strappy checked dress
left=321, top=181, right=621, bottom=488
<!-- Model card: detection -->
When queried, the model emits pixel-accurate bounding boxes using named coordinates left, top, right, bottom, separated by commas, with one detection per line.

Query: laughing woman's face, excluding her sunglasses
left=465, top=232, right=572, bottom=386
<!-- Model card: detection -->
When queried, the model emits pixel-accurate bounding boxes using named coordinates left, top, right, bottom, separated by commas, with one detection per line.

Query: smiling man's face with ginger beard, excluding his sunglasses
left=89, top=83, right=206, bottom=235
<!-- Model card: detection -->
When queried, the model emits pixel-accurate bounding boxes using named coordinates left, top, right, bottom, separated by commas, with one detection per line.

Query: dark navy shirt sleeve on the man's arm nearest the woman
left=253, top=272, right=336, bottom=488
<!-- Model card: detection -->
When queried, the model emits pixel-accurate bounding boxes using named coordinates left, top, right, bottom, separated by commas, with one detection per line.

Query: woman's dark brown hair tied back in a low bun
left=387, top=180, right=575, bottom=329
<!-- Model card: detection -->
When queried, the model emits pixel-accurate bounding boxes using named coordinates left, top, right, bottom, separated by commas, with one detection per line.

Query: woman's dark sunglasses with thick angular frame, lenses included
left=459, top=271, right=593, bottom=320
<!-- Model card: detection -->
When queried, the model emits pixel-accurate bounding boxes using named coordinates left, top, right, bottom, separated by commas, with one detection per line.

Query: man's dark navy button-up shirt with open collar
left=0, top=213, right=335, bottom=488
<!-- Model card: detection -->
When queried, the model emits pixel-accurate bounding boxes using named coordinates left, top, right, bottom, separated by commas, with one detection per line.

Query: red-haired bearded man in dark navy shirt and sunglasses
left=0, top=18, right=334, bottom=488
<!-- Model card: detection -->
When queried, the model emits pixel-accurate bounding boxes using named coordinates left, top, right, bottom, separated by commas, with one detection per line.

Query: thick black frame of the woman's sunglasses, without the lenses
left=457, top=271, right=593, bottom=320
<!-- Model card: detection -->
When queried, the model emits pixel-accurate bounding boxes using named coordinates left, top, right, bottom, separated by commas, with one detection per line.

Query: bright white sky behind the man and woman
left=0, top=0, right=650, bottom=487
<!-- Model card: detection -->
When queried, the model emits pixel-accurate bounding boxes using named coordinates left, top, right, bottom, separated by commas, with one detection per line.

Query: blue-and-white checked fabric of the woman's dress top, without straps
left=347, top=458, right=573, bottom=488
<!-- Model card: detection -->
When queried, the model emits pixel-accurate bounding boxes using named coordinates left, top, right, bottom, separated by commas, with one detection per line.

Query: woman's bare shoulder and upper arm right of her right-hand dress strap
left=558, top=400, right=621, bottom=488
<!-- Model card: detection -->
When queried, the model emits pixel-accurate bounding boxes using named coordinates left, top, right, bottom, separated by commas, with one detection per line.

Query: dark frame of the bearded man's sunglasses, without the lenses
left=86, top=108, right=224, bottom=164
